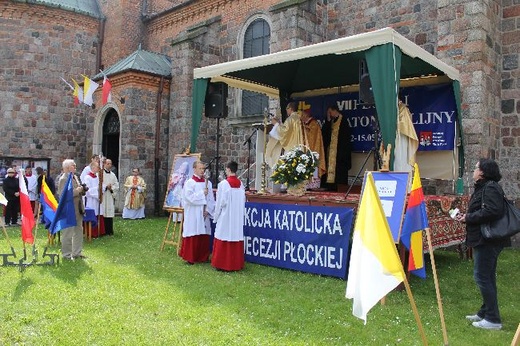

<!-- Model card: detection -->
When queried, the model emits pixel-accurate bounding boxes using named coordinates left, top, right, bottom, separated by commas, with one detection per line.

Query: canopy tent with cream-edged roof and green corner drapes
left=191, top=28, right=464, bottom=177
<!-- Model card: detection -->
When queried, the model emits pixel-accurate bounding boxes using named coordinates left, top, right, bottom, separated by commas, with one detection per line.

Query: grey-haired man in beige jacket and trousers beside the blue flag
left=58, top=159, right=87, bottom=260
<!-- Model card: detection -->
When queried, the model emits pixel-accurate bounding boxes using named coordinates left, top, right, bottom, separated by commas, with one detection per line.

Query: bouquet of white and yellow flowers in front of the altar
left=271, top=145, right=319, bottom=186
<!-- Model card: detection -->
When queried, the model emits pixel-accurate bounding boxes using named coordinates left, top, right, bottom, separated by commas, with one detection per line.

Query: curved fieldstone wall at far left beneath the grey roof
left=0, top=3, right=98, bottom=173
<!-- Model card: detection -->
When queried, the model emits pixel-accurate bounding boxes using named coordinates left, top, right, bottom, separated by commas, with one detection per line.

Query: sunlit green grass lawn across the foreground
left=0, top=218, right=520, bottom=346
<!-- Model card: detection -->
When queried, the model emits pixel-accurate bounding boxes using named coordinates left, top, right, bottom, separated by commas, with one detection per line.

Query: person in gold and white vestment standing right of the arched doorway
left=123, top=168, right=146, bottom=220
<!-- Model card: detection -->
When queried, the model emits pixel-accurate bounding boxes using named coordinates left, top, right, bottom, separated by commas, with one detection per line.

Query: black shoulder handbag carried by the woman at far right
left=480, top=188, right=520, bottom=239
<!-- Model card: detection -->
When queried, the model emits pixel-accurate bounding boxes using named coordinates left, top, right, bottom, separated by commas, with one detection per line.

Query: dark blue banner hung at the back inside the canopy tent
left=296, top=84, right=457, bottom=152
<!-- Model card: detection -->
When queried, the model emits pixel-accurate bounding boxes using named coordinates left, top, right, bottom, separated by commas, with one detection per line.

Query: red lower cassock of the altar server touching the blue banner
left=211, top=238, right=244, bottom=271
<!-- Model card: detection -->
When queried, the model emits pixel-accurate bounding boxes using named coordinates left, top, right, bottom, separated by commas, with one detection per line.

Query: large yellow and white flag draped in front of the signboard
left=345, top=173, right=405, bottom=324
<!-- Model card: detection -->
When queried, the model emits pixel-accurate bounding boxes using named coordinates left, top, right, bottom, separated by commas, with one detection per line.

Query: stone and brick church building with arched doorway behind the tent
left=0, top=0, right=520, bottom=214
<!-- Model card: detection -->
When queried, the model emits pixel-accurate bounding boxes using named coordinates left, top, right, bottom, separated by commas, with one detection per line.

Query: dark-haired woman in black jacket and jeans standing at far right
left=456, top=158, right=511, bottom=329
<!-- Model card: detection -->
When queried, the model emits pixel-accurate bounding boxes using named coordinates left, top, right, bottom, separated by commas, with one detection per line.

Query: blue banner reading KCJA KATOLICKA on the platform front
left=244, top=202, right=353, bottom=279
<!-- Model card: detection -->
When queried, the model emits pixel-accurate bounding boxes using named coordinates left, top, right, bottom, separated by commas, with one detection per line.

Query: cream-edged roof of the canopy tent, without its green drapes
left=194, top=28, right=459, bottom=97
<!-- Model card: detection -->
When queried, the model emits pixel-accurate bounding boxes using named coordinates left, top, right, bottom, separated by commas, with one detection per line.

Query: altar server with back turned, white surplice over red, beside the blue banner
left=211, top=161, right=246, bottom=271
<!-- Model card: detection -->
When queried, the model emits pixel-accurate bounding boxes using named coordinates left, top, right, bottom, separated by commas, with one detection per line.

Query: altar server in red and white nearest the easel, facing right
left=181, top=161, right=215, bottom=264
